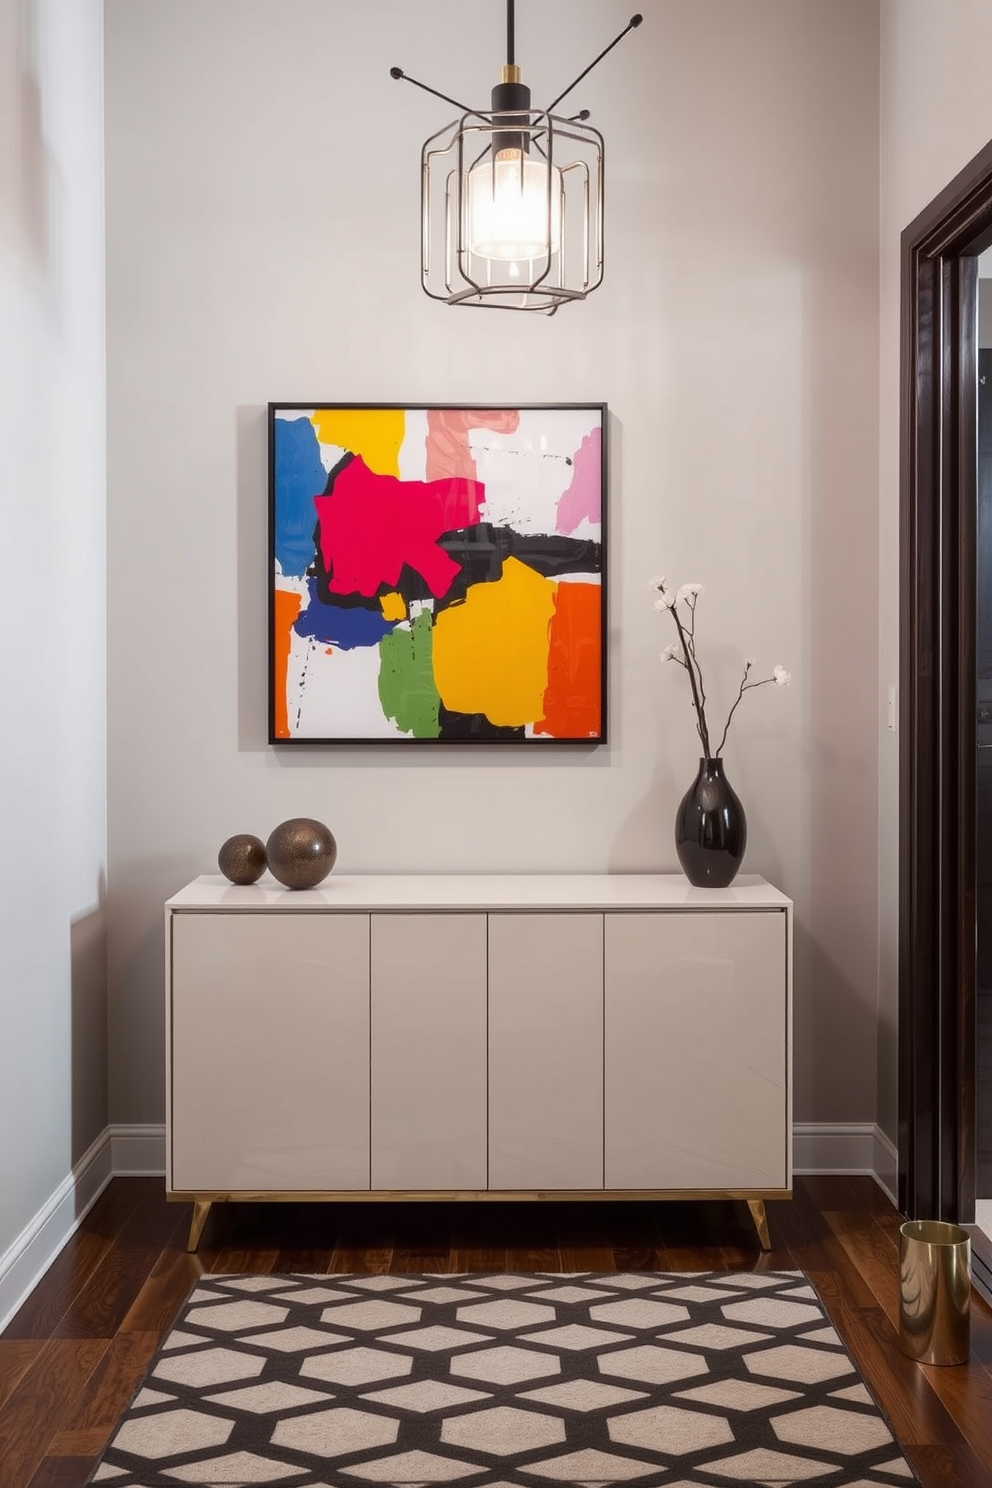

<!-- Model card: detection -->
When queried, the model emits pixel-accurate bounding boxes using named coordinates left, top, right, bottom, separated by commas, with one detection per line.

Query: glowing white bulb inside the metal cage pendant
left=468, top=150, right=562, bottom=263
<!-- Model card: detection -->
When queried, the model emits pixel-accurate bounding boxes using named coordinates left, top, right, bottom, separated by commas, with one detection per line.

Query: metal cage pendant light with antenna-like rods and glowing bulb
left=390, top=0, right=642, bottom=315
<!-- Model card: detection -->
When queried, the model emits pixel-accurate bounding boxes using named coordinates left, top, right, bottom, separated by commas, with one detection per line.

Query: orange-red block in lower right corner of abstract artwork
left=534, top=582, right=602, bottom=740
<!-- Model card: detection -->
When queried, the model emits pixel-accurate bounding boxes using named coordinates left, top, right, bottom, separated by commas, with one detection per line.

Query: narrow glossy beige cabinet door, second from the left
left=372, top=912, right=486, bottom=1190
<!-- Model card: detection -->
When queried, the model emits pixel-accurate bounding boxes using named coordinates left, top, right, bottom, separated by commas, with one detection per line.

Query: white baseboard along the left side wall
left=0, top=1131, right=113, bottom=1332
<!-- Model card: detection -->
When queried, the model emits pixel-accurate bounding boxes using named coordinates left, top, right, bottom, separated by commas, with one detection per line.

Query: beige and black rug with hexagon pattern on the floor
left=89, top=1271, right=916, bottom=1488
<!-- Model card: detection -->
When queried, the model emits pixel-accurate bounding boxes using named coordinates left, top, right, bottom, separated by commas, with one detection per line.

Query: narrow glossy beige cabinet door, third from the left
left=489, top=914, right=602, bottom=1189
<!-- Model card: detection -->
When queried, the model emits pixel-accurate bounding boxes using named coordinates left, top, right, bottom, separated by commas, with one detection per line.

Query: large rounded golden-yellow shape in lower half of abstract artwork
left=434, top=558, right=558, bottom=728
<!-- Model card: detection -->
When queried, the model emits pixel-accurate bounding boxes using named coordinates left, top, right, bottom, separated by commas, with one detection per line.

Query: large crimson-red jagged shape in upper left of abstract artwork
left=314, top=457, right=485, bottom=598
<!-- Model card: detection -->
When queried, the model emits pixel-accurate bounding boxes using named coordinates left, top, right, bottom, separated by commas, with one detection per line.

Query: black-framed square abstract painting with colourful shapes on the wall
left=269, top=403, right=605, bottom=745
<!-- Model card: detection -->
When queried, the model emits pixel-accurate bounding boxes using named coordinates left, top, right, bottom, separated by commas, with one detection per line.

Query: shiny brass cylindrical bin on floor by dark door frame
left=898, top=1219, right=971, bottom=1364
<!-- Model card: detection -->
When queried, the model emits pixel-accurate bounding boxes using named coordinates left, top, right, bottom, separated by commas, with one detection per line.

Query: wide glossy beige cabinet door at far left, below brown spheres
left=170, top=914, right=369, bottom=1192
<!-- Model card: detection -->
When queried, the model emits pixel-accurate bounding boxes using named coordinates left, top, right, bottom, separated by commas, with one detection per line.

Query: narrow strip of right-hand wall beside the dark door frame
left=879, top=0, right=992, bottom=1137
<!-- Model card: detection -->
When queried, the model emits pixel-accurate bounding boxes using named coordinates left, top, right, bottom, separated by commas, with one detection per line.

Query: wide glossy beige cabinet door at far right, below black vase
left=605, top=909, right=788, bottom=1189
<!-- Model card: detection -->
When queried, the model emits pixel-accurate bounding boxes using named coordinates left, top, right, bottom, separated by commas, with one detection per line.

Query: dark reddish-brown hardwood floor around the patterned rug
left=0, top=1177, right=992, bottom=1488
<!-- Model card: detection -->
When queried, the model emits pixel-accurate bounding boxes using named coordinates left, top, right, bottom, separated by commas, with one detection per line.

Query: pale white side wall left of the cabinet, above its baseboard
left=0, top=0, right=107, bottom=1267
